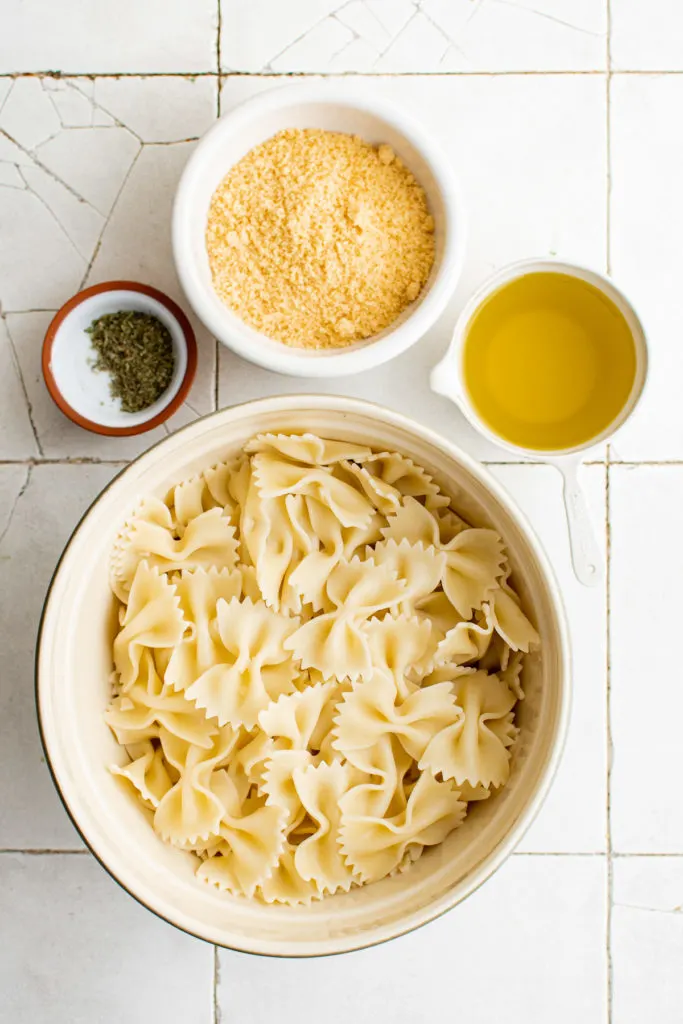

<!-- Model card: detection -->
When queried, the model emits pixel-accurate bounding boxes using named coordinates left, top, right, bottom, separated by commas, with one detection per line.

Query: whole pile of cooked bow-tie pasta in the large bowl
left=105, top=434, right=539, bottom=903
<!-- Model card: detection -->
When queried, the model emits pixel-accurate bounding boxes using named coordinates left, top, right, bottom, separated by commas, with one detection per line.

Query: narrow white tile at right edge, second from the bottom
left=610, top=466, right=683, bottom=853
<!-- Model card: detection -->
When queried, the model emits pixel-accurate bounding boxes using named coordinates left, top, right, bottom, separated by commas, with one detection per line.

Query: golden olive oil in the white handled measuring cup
left=463, top=272, right=636, bottom=451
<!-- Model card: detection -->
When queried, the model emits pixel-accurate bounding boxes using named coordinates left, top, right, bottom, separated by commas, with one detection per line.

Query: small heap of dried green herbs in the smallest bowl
left=87, top=309, right=175, bottom=413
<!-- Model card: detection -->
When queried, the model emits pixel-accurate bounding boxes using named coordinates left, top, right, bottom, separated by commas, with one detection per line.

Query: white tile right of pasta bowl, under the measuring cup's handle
left=493, top=466, right=607, bottom=853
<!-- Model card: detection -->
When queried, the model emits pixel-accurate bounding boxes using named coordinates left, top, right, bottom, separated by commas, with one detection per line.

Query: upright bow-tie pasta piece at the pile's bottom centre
left=294, top=761, right=354, bottom=893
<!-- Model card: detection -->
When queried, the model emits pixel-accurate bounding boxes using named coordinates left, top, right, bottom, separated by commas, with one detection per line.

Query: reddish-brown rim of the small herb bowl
left=41, top=281, right=197, bottom=437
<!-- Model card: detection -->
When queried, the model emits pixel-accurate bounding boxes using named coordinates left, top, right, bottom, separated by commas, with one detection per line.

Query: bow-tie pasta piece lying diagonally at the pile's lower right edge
left=340, top=772, right=467, bottom=883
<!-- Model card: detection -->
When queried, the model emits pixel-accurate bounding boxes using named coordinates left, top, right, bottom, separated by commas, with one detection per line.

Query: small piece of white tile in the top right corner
left=611, top=0, right=683, bottom=71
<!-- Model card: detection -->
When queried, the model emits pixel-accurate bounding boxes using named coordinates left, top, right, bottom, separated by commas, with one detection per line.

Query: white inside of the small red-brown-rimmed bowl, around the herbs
left=50, top=289, right=187, bottom=427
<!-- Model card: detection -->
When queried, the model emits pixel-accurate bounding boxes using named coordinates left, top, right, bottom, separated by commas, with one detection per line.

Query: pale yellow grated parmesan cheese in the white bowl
left=206, top=129, right=434, bottom=348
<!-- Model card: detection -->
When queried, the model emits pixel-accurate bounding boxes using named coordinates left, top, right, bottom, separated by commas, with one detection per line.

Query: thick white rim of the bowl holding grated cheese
left=171, top=80, right=467, bottom=379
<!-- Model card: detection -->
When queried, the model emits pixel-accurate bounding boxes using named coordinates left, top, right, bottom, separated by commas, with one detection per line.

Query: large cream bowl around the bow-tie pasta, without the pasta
left=37, top=395, right=569, bottom=956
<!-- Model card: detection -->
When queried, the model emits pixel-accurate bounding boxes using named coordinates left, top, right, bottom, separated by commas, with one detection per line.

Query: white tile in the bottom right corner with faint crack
left=611, top=857, right=683, bottom=1024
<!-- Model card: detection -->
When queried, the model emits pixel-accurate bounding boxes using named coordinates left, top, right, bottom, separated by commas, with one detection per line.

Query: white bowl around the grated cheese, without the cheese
left=173, top=82, right=465, bottom=377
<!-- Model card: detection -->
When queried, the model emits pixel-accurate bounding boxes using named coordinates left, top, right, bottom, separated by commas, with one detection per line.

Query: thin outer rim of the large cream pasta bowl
left=34, top=394, right=572, bottom=959
